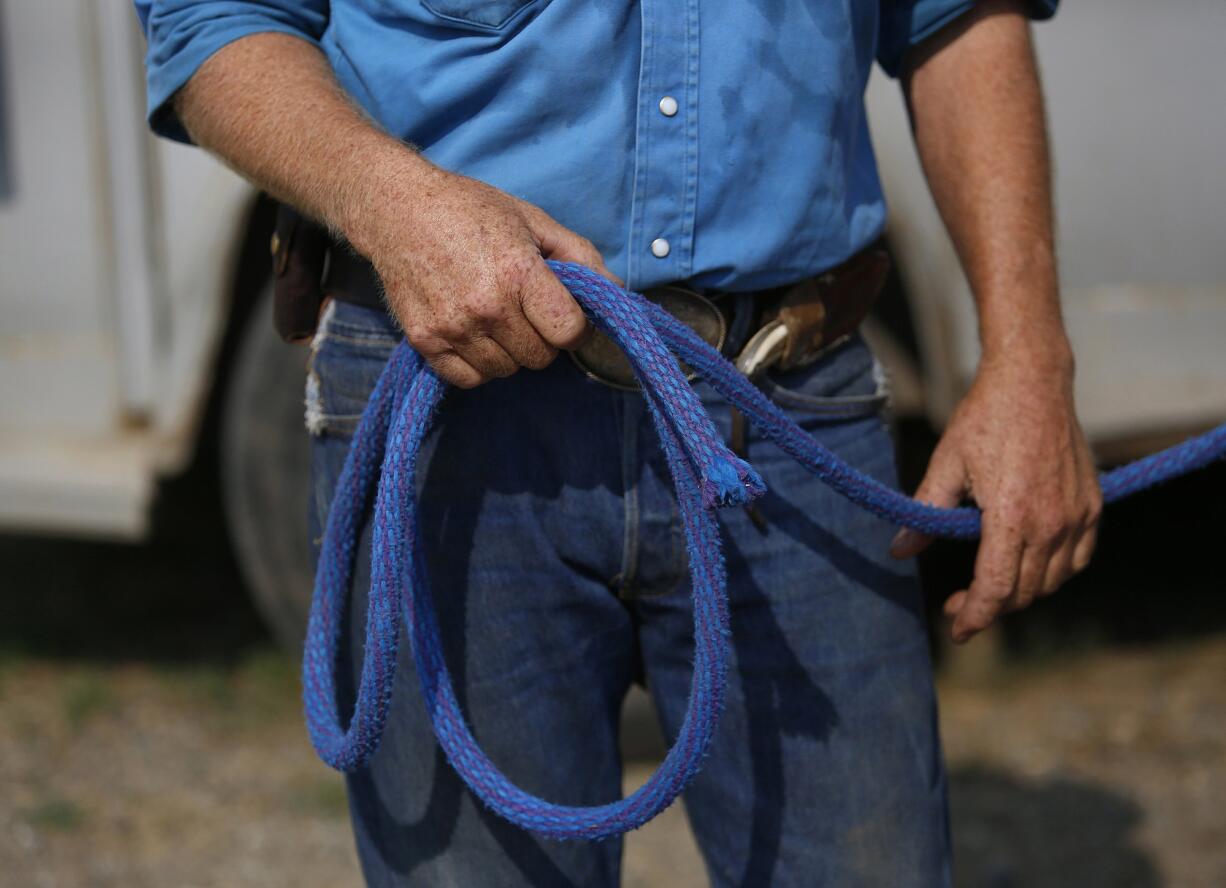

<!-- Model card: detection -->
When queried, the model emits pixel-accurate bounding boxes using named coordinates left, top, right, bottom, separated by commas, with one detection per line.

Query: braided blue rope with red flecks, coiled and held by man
left=303, top=262, right=1226, bottom=839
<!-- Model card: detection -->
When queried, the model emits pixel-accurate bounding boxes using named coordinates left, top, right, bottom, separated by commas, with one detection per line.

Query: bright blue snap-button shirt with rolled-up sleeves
left=136, top=0, right=1057, bottom=289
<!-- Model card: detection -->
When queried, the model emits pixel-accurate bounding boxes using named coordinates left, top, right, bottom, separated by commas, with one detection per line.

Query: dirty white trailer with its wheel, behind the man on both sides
left=0, top=0, right=1226, bottom=639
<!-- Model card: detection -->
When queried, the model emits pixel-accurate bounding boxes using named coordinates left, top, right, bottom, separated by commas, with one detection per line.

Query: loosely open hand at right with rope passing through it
left=890, top=350, right=1102, bottom=643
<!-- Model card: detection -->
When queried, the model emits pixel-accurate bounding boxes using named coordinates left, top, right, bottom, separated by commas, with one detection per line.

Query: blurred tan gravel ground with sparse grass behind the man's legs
left=0, top=637, right=1226, bottom=888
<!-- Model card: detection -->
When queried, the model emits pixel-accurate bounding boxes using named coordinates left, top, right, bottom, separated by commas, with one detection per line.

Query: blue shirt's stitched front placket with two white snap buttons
left=628, top=0, right=699, bottom=287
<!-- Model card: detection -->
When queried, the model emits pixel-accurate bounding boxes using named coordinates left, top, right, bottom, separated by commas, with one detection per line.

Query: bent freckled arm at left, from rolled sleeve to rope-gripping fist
left=174, top=33, right=615, bottom=388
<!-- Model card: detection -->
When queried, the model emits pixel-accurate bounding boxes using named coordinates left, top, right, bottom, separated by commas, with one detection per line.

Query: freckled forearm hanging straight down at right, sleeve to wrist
left=905, top=0, right=1072, bottom=375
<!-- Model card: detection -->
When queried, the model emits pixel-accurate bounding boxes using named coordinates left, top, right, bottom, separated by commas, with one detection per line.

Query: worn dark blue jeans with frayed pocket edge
left=308, top=304, right=949, bottom=888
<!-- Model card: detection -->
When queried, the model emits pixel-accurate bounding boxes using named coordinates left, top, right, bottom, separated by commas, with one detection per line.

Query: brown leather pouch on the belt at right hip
left=763, top=250, right=890, bottom=370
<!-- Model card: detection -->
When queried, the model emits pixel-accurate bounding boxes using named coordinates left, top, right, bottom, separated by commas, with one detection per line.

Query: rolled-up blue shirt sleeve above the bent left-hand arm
left=135, top=0, right=329, bottom=142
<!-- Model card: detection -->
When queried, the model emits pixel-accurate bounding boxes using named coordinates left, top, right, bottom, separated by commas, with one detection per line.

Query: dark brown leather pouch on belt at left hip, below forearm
left=272, top=204, right=330, bottom=342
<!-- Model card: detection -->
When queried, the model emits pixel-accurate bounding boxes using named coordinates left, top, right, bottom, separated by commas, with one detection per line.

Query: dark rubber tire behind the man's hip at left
left=221, top=283, right=314, bottom=650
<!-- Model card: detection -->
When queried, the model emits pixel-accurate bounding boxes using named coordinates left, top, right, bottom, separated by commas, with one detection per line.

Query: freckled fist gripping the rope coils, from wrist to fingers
left=353, top=166, right=615, bottom=389
